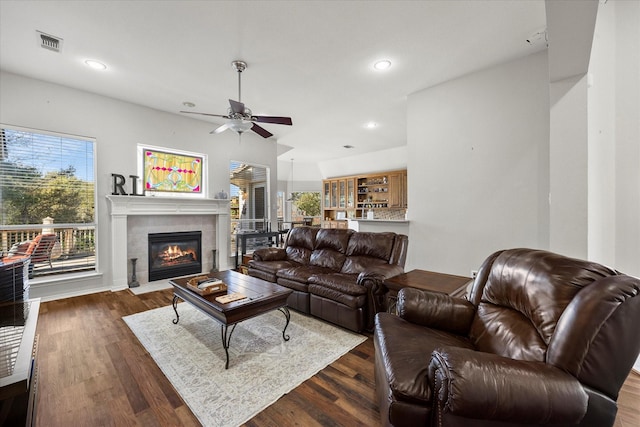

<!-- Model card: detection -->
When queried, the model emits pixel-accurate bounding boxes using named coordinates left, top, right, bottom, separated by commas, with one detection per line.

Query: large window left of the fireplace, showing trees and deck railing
left=0, top=126, right=95, bottom=277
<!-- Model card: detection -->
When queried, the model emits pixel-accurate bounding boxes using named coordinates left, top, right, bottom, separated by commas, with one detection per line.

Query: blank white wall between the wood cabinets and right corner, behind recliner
left=407, top=52, right=549, bottom=275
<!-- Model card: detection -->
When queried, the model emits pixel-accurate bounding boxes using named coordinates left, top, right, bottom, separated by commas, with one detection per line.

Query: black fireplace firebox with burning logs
left=148, top=231, right=202, bottom=282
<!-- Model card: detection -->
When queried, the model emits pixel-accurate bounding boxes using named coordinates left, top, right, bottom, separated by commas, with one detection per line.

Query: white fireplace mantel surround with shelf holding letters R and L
left=107, top=195, right=229, bottom=290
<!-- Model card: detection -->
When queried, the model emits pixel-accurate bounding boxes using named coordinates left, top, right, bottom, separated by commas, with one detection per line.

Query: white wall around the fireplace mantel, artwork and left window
left=0, top=72, right=277, bottom=297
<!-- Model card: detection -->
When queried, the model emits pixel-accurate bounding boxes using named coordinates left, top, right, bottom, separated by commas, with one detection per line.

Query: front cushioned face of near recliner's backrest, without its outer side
left=471, top=249, right=616, bottom=361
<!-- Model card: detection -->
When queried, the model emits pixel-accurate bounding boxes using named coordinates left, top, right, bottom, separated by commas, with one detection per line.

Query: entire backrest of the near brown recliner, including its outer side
left=469, top=249, right=640, bottom=399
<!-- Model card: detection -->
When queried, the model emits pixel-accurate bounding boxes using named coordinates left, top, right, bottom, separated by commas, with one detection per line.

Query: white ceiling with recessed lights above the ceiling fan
left=0, top=0, right=546, bottom=162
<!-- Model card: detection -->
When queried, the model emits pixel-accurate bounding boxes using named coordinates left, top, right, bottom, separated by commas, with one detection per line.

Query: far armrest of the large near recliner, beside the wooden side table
left=396, top=288, right=476, bottom=335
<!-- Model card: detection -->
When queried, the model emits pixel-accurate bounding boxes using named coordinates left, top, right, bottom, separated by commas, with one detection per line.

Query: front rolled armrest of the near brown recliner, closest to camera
left=428, top=347, right=588, bottom=425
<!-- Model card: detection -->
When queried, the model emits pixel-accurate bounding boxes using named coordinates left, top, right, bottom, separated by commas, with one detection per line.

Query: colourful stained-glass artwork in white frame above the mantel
left=142, top=148, right=204, bottom=194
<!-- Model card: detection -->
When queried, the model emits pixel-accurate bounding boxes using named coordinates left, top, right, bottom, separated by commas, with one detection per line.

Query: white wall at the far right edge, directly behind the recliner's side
left=588, top=1, right=640, bottom=372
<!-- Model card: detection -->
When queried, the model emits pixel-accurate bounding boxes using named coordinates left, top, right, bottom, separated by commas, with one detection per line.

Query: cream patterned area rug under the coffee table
left=123, top=303, right=366, bottom=426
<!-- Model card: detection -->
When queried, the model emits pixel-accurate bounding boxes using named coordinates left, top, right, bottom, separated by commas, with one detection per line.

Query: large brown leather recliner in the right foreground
left=374, top=249, right=640, bottom=427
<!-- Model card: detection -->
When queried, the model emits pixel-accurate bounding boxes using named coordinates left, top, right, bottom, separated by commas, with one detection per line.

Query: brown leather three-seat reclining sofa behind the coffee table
left=249, top=227, right=408, bottom=332
